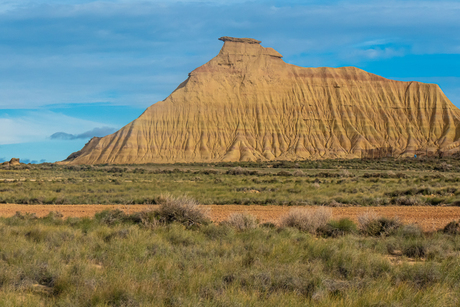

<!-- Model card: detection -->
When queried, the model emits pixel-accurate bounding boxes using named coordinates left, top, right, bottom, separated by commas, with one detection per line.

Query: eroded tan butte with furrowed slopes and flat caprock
left=66, top=37, right=460, bottom=164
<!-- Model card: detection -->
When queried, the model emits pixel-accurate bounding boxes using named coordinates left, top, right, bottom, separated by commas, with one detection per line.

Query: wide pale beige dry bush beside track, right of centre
left=280, top=207, right=332, bottom=234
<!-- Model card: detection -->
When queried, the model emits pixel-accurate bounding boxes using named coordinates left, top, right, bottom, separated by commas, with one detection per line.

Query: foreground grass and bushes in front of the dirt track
left=0, top=198, right=460, bottom=307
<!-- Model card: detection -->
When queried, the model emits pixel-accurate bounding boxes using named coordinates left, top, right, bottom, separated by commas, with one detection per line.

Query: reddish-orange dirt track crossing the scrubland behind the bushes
left=0, top=204, right=460, bottom=231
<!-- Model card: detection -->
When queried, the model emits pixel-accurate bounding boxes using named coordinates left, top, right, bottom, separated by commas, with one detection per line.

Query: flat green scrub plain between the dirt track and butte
left=0, top=158, right=460, bottom=206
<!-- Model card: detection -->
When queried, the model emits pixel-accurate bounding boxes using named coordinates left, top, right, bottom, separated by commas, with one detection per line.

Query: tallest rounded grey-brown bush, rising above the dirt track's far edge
left=156, top=196, right=209, bottom=227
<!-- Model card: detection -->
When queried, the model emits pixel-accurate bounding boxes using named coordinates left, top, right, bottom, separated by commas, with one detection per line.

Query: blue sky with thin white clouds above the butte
left=0, top=0, right=460, bottom=162
